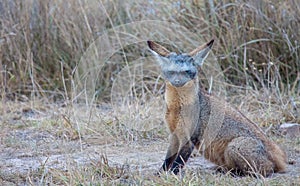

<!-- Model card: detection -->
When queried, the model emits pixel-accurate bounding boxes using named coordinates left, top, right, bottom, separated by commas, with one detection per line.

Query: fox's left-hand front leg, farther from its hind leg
left=160, top=134, right=179, bottom=172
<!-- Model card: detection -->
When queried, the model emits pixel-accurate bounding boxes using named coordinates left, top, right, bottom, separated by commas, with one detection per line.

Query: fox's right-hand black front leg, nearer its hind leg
left=171, top=141, right=194, bottom=175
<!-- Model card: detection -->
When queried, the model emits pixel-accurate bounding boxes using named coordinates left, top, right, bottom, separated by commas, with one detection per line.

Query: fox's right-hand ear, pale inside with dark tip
left=189, top=40, right=214, bottom=66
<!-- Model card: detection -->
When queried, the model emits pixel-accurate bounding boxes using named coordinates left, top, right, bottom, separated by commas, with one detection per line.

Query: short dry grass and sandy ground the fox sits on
left=0, top=102, right=300, bottom=185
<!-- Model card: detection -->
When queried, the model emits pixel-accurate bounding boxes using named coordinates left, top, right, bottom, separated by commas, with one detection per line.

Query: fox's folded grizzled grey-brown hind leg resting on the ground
left=224, top=137, right=274, bottom=176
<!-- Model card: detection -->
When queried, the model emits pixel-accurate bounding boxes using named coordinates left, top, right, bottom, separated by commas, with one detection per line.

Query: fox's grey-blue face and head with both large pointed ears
left=148, top=40, right=214, bottom=87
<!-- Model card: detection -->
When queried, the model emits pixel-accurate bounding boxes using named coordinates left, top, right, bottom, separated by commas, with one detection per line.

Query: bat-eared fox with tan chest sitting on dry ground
left=147, top=39, right=287, bottom=177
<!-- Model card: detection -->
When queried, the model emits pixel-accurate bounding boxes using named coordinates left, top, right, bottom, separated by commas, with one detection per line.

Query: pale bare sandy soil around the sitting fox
left=0, top=103, right=300, bottom=184
